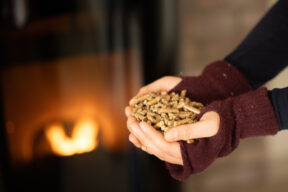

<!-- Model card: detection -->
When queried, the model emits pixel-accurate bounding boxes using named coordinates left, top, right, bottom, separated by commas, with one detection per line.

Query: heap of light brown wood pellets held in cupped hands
left=131, top=90, right=204, bottom=143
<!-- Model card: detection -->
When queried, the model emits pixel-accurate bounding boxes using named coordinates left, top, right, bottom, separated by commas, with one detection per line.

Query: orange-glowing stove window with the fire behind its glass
left=2, top=53, right=139, bottom=164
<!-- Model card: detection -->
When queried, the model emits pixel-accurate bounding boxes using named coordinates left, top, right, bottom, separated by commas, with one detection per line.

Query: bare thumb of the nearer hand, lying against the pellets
left=165, top=111, right=220, bottom=142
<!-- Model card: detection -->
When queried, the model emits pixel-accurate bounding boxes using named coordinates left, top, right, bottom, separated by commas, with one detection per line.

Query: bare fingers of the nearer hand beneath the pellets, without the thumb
left=125, top=107, right=183, bottom=165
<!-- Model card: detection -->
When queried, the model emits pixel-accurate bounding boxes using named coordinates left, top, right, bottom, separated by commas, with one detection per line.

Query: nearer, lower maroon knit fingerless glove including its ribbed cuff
left=166, top=88, right=278, bottom=180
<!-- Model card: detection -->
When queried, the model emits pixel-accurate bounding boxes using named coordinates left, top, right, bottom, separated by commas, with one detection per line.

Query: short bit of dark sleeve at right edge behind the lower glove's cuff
left=268, top=87, right=288, bottom=130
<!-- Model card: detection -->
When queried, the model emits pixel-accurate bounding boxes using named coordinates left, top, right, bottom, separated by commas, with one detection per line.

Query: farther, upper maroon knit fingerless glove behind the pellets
left=171, top=60, right=251, bottom=104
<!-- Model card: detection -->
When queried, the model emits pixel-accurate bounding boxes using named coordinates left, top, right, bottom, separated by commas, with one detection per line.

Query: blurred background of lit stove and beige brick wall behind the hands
left=0, top=0, right=288, bottom=192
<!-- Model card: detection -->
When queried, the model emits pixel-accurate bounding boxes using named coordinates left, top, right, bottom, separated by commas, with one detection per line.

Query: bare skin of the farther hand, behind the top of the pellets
left=129, top=76, right=182, bottom=104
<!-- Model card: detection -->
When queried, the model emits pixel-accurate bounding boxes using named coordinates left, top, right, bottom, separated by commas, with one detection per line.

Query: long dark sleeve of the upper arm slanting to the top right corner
left=225, top=0, right=288, bottom=89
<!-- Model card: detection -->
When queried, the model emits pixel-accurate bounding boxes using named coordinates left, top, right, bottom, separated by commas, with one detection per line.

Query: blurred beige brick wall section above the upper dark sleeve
left=179, top=0, right=270, bottom=74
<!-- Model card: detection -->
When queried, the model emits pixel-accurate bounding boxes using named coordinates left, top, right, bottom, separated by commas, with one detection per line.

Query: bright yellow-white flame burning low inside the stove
left=45, top=119, right=99, bottom=156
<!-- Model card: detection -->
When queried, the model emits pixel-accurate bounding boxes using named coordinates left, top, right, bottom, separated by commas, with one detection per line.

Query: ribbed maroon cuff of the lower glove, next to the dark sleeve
left=233, top=88, right=279, bottom=138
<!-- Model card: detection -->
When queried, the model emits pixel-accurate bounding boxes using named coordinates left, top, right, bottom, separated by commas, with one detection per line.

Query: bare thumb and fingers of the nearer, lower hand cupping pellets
left=125, top=107, right=220, bottom=165
